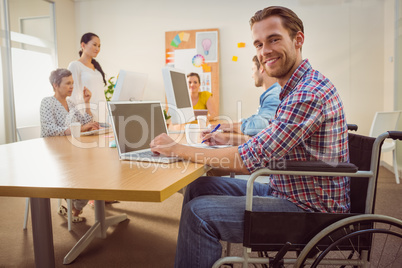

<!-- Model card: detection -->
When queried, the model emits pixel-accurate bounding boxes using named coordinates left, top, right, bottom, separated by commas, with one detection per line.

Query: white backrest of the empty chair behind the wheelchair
left=369, top=111, right=401, bottom=137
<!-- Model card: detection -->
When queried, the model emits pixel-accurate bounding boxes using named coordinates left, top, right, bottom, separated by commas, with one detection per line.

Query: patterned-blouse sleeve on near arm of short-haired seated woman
left=40, top=98, right=68, bottom=137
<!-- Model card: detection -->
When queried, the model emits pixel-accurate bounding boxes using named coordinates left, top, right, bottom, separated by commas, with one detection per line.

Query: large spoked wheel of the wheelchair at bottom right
left=295, top=214, right=402, bottom=267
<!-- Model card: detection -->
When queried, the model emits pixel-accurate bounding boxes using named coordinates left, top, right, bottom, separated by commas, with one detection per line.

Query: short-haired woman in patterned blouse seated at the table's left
left=40, top=69, right=99, bottom=223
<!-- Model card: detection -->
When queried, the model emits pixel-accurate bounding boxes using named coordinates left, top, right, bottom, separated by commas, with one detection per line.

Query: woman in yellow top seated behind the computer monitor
left=187, top=73, right=217, bottom=120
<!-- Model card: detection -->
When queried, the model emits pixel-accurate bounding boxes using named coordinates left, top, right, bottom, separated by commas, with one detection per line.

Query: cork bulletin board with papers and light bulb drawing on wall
left=165, top=29, right=220, bottom=118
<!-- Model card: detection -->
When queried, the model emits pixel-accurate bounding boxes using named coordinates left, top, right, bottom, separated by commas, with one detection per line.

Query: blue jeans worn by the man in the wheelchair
left=175, top=177, right=303, bottom=268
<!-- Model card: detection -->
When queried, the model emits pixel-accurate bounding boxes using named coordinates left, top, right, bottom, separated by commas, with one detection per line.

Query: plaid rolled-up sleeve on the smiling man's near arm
left=239, top=92, right=330, bottom=172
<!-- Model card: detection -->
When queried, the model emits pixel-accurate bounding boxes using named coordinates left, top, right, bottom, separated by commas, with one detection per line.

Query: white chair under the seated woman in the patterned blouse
left=17, top=126, right=73, bottom=231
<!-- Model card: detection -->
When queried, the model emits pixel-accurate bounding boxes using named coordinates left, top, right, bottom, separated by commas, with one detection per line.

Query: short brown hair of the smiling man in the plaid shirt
left=250, top=6, right=304, bottom=39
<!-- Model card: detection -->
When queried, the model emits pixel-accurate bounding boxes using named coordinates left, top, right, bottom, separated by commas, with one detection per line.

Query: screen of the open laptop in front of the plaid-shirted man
left=109, top=102, right=167, bottom=154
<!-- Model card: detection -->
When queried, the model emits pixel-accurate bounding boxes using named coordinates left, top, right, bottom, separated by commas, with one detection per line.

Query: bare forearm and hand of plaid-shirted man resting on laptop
left=150, top=134, right=249, bottom=174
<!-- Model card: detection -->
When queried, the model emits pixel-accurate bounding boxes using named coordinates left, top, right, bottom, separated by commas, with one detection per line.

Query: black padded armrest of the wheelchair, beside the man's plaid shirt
left=271, top=161, right=358, bottom=173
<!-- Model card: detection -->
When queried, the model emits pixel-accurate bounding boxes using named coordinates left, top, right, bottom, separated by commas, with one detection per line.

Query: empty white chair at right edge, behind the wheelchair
left=369, top=111, right=401, bottom=184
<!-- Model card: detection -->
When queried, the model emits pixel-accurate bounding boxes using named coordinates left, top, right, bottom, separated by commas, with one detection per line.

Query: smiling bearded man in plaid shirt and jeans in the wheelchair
left=151, top=7, right=350, bottom=268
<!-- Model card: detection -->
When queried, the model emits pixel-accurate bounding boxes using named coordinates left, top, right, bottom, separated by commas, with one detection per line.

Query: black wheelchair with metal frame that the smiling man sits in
left=212, top=129, right=402, bottom=268
